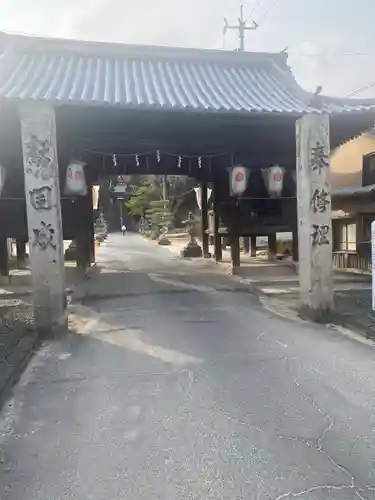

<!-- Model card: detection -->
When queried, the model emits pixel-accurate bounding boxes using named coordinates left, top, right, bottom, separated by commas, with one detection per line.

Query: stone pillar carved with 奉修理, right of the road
left=296, top=113, right=333, bottom=320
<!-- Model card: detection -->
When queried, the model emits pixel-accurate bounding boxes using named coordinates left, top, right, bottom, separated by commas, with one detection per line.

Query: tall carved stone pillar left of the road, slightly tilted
left=20, top=102, right=67, bottom=334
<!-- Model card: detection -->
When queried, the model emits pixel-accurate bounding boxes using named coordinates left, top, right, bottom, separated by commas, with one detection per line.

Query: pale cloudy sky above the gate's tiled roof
left=0, top=0, right=375, bottom=97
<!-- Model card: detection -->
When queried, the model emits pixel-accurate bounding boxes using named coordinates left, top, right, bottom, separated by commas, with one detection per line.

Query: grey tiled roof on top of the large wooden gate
left=0, top=34, right=375, bottom=115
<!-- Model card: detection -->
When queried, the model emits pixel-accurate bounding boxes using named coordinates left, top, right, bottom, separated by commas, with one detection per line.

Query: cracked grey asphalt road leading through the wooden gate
left=0, top=235, right=375, bottom=500
